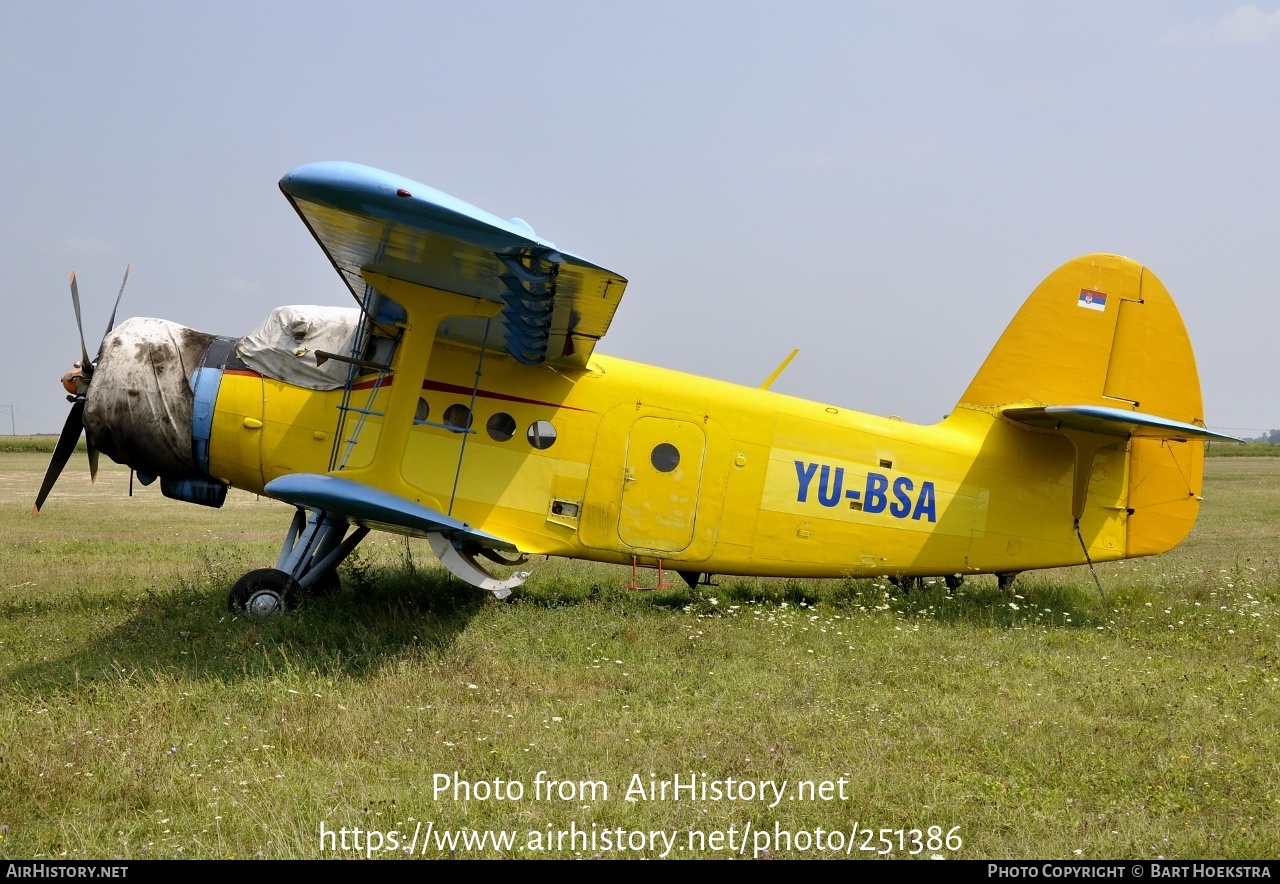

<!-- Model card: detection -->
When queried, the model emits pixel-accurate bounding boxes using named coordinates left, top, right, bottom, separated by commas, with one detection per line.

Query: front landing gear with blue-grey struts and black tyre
left=227, top=507, right=369, bottom=617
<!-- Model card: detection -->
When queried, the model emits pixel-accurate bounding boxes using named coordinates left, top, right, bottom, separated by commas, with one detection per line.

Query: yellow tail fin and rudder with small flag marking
left=960, top=255, right=1211, bottom=555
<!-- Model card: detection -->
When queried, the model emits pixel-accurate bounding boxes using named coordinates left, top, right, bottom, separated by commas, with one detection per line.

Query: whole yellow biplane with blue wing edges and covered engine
left=36, top=162, right=1228, bottom=614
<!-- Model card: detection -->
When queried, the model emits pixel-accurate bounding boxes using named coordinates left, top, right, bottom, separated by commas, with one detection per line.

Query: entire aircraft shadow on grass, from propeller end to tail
left=4, top=568, right=1102, bottom=693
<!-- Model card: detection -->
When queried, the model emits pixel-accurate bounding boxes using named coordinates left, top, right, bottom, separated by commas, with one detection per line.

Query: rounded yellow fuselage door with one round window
left=618, top=417, right=707, bottom=553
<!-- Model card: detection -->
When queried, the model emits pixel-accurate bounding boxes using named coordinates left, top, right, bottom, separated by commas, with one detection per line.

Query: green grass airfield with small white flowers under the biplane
left=0, top=453, right=1280, bottom=858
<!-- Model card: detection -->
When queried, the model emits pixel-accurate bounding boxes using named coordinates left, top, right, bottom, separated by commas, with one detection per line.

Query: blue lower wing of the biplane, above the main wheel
left=265, top=473, right=518, bottom=551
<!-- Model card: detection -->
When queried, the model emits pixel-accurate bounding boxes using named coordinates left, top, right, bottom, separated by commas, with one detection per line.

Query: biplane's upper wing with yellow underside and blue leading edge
left=280, top=162, right=627, bottom=366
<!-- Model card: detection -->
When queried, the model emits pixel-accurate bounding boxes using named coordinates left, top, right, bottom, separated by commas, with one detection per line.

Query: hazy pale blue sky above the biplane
left=0, top=0, right=1280, bottom=436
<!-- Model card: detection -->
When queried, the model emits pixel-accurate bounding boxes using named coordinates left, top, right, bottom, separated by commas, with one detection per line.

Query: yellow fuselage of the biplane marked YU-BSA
left=209, top=340, right=1129, bottom=577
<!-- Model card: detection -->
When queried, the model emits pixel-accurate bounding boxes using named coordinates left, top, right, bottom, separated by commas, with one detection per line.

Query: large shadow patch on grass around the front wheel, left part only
left=3, top=560, right=495, bottom=693
